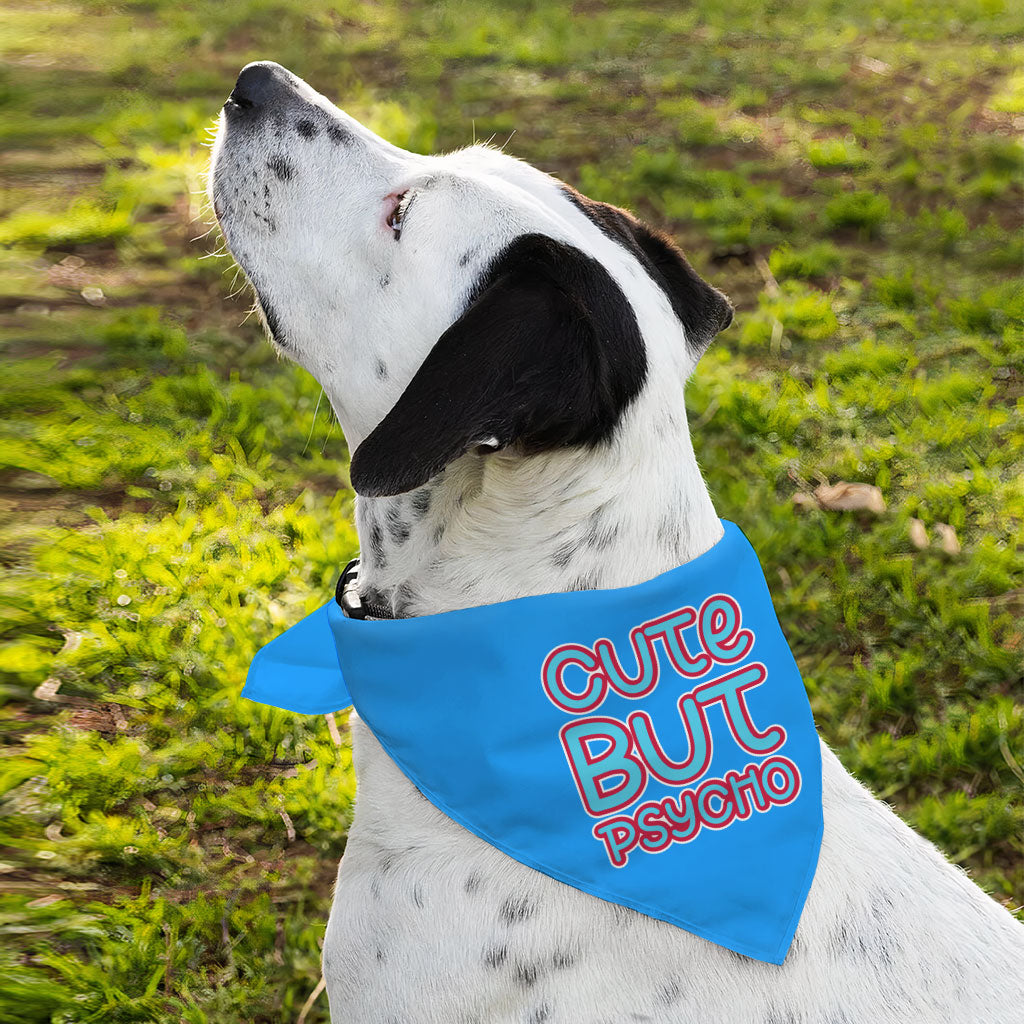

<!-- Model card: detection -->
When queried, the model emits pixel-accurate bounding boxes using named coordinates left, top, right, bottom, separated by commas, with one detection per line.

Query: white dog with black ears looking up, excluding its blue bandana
left=210, top=61, right=1024, bottom=1024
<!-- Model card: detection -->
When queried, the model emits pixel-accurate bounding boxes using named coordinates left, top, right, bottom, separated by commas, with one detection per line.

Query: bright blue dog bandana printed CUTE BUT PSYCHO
left=243, top=522, right=822, bottom=964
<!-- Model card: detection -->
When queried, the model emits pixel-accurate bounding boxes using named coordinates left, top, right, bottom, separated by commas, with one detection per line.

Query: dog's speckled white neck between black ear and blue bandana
left=356, top=393, right=722, bottom=616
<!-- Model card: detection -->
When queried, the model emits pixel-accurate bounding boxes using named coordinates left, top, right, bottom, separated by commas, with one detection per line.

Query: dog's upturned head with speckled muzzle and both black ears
left=211, top=62, right=732, bottom=495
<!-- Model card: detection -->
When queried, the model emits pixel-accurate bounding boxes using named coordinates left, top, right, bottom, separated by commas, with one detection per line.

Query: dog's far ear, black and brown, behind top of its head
left=562, top=185, right=732, bottom=358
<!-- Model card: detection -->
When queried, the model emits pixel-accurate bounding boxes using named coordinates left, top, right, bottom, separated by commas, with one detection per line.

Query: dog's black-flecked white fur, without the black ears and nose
left=212, top=64, right=1024, bottom=1024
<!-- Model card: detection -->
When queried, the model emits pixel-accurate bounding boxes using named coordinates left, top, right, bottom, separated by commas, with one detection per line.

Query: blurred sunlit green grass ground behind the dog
left=0, top=0, right=1024, bottom=1024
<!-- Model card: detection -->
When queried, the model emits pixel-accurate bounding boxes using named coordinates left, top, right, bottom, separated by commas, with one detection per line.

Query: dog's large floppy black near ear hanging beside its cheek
left=350, top=234, right=647, bottom=496
